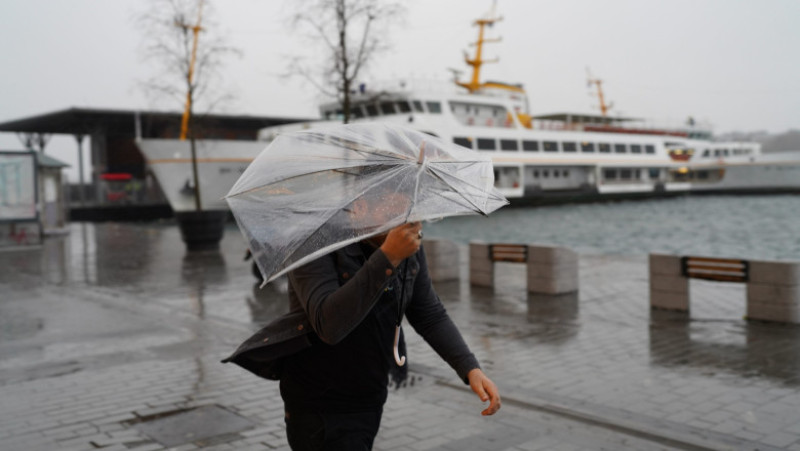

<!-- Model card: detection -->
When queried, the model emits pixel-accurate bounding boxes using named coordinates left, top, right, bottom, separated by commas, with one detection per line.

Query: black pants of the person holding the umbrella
left=286, top=408, right=383, bottom=451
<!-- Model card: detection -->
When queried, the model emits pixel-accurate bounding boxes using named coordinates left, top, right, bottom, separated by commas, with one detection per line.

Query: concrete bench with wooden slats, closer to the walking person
left=469, top=241, right=578, bottom=294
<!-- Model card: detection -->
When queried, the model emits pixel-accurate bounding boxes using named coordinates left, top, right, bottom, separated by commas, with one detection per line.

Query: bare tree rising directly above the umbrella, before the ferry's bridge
left=288, top=0, right=405, bottom=123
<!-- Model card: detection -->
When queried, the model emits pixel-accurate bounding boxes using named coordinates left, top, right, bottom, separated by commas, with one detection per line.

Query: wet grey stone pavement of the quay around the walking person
left=0, top=222, right=800, bottom=451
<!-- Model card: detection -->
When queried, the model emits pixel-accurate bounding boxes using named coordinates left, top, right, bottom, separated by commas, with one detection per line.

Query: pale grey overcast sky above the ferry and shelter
left=0, top=0, right=800, bottom=182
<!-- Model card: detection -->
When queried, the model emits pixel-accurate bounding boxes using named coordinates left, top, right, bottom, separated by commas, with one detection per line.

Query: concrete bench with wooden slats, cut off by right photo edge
left=650, top=254, right=800, bottom=323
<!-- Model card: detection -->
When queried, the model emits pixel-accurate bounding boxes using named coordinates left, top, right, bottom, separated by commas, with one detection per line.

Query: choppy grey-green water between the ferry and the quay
left=424, top=195, right=800, bottom=261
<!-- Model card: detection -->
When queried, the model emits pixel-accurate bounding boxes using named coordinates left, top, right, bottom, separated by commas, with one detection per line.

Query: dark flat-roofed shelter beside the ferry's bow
left=0, top=108, right=308, bottom=220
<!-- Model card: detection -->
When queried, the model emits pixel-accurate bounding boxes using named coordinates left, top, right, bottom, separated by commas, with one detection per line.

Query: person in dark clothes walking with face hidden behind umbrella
left=280, top=216, right=501, bottom=451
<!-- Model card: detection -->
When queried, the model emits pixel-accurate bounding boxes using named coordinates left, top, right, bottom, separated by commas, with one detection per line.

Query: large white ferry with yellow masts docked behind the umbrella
left=139, top=4, right=800, bottom=211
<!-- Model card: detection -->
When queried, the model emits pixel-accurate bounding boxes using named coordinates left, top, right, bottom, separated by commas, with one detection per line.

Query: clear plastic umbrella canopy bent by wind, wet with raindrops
left=226, top=123, right=508, bottom=283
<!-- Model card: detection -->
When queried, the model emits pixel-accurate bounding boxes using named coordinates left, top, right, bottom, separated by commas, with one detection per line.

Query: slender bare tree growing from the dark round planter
left=136, top=0, right=240, bottom=211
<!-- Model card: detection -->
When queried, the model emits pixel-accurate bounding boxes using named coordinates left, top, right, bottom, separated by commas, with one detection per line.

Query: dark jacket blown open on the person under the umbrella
left=223, top=243, right=479, bottom=382
